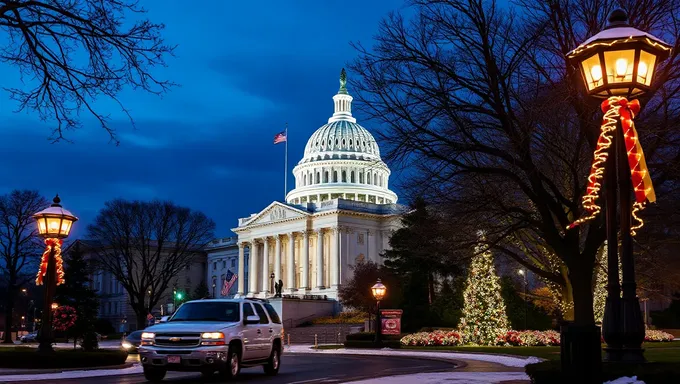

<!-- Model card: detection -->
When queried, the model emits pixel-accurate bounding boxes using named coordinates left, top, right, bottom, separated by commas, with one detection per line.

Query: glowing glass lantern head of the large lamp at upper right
left=567, top=10, right=671, bottom=99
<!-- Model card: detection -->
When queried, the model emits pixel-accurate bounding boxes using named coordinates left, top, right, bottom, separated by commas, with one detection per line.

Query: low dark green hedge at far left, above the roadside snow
left=0, top=347, right=127, bottom=369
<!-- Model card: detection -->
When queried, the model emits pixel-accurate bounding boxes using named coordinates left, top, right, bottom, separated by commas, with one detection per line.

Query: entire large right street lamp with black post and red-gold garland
left=567, top=10, right=671, bottom=362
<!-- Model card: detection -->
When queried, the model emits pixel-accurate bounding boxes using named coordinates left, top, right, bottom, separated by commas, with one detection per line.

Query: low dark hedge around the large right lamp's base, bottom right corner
left=525, top=360, right=680, bottom=384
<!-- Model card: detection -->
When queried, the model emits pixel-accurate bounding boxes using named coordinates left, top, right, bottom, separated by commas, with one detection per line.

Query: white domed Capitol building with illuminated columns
left=207, top=70, right=404, bottom=317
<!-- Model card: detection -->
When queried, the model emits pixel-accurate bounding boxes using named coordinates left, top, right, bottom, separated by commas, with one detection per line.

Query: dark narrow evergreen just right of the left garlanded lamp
left=55, top=242, right=99, bottom=348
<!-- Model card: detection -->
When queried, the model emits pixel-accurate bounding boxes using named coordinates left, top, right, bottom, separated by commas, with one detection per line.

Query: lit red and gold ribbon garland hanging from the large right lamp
left=567, top=96, right=656, bottom=236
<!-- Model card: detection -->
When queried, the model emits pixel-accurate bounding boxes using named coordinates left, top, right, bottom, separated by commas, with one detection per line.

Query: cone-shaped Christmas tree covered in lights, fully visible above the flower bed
left=459, top=232, right=509, bottom=344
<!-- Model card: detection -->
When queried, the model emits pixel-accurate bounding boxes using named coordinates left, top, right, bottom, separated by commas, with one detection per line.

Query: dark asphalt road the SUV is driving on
left=6, top=354, right=454, bottom=384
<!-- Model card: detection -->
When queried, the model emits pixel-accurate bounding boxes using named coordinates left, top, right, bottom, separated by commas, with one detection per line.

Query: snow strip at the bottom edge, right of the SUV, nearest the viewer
left=351, top=372, right=529, bottom=384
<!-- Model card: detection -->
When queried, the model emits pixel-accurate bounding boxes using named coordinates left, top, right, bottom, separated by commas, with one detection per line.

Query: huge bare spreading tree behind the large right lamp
left=352, top=0, right=680, bottom=325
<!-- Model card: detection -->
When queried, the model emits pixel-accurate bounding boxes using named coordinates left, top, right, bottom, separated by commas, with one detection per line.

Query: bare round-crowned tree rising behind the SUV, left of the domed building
left=87, top=200, right=215, bottom=329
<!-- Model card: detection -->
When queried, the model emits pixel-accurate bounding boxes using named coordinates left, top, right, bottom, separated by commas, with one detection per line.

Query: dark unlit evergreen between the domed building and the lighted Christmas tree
left=383, top=198, right=461, bottom=329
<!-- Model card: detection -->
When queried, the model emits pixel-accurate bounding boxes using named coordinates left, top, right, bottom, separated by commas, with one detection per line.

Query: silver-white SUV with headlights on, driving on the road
left=139, top=299, right=283, bottom=382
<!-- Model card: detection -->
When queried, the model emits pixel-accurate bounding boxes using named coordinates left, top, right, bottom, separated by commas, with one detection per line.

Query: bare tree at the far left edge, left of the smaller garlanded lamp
left=0, top=190, right=49, bottom=343
